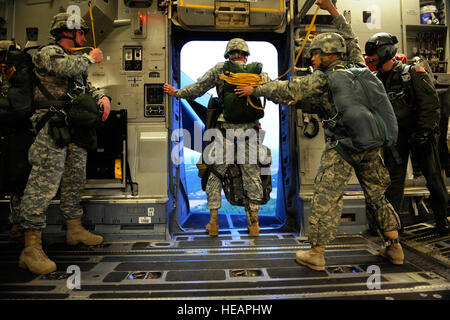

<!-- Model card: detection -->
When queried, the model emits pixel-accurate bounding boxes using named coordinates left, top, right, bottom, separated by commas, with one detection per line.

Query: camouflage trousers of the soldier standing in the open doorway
left=206, top=122, right=263, bottom=212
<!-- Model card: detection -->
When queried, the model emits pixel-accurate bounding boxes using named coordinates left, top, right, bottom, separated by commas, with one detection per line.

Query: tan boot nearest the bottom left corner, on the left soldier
left=19, top=230, right=56, bottom=274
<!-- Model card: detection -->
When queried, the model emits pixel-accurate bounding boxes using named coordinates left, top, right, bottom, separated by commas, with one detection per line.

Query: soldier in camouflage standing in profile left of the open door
left=19, top=13, right=110, bottom=274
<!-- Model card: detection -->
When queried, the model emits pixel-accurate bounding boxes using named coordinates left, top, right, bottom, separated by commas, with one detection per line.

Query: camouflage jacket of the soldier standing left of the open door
left=33, top=44, right=104, bottom=106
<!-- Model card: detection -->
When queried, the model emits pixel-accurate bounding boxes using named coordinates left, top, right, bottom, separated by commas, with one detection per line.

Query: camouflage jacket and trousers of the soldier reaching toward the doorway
left=253, top=15, right=400, bottom=246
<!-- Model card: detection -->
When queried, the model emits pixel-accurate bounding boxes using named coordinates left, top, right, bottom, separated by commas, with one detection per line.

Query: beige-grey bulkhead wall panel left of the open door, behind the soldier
left=8, top=0, right=170, bottom=234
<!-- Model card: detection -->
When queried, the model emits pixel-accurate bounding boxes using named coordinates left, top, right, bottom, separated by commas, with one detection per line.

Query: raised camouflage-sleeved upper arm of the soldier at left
left=33, top=45, right=95, bottom=78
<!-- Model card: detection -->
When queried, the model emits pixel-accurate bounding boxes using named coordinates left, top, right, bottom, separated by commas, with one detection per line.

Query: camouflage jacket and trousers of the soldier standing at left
left=21, top=44, right=104, bottom=230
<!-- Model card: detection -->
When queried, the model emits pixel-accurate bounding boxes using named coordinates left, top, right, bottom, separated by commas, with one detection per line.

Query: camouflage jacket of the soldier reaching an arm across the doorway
left=253, top=15, right=365, bottom=119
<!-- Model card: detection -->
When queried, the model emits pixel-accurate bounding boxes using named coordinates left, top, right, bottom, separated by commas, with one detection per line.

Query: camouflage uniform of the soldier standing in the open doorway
left=175, top=50, right=270, bottom=212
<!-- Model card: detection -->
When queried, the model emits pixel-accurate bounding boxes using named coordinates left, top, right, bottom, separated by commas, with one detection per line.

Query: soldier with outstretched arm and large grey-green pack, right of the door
left=236, top=0, right=404, bottom=270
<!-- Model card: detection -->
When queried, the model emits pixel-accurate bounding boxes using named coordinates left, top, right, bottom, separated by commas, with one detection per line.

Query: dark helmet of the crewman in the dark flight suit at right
left=365, top=32, right=398, bottom=67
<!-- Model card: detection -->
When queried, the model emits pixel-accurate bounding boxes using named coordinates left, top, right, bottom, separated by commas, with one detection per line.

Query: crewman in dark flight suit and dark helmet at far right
left=365, top=32, right=449, bottom=235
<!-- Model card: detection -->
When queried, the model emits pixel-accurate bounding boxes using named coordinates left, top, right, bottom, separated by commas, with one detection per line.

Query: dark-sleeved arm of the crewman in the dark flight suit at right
left=411, top=67, right=440, bottom=133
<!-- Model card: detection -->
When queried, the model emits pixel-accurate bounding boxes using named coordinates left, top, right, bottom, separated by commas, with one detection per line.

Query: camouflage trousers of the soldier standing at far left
left=20, top=114, right=87, bottom=230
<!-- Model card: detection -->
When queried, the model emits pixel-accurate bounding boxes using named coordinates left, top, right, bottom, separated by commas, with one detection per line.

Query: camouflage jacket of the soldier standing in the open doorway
left=175, top=62, right=271, bottom=121
